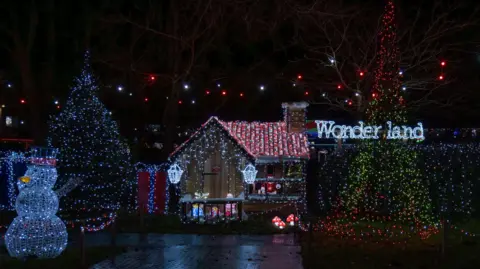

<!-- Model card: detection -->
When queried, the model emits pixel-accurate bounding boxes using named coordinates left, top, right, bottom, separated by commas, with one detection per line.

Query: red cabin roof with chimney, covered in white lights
left=170, top=102, right=310, bottom=162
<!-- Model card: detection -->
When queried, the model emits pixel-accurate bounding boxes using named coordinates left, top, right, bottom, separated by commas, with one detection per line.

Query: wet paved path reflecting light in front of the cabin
left=87, top=232, right=303, bottom=269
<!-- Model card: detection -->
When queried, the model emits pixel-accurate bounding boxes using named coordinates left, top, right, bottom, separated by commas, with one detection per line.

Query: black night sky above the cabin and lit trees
left=0, top=0, right=480, bottom=142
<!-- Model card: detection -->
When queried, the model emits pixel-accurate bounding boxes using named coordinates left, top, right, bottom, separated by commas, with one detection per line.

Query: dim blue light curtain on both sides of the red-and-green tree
left=318, top=144, right=480, bottom=239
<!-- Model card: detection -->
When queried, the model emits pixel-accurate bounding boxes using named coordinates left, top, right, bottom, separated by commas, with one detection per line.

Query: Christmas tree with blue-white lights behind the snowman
left=49, top=52, right=135, bottom=212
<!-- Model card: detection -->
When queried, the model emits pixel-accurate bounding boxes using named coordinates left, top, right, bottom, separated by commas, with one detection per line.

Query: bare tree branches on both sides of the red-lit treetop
left=297, top=1, right=480, bottom=117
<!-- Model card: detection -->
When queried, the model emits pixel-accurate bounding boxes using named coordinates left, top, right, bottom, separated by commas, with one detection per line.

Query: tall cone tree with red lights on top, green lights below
left=342, top=1, right=433, bottom=225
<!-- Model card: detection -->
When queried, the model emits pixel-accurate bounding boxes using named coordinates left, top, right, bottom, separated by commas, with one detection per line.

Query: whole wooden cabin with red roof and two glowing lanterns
left=168, top=102, right=309, bottom=222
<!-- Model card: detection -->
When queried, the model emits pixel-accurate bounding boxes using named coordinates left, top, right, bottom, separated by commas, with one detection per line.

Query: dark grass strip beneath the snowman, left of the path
left=0, top=247, right=126, bottom=269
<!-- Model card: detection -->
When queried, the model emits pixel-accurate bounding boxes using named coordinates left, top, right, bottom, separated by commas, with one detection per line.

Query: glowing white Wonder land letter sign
left=315, top=120, right=425, bottom=140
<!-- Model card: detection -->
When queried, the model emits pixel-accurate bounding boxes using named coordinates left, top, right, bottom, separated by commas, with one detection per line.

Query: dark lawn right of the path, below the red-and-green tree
left=301, top=230, right=480, bottom=269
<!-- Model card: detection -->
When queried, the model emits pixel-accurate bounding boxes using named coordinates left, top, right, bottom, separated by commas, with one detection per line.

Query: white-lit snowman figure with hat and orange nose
left=5, top=148, right=75, bottom=259
